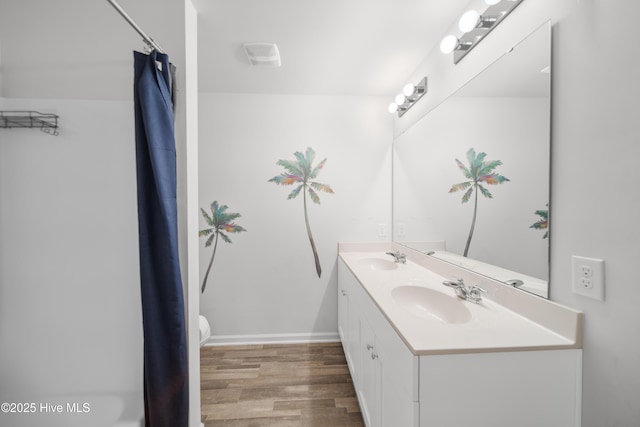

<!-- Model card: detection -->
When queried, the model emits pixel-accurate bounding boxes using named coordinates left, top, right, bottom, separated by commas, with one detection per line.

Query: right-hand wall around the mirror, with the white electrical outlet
left=396, top=0, right=640, bottom=427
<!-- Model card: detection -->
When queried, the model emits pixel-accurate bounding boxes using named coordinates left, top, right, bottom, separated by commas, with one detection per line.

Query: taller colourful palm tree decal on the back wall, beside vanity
left=269, top=148, right=333, bottom=277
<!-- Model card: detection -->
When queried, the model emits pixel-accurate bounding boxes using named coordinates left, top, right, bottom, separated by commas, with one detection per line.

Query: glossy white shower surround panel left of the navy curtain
left=0, top=98, right=142, bottom=418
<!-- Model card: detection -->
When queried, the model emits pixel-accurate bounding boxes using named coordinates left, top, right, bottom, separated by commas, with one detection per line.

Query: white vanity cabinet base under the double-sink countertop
left=338, top=254, right=582, bottom=427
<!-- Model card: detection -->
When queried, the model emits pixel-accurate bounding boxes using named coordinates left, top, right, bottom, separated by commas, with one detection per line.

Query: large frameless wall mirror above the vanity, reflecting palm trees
left=393, top=23, right=551, bottom=297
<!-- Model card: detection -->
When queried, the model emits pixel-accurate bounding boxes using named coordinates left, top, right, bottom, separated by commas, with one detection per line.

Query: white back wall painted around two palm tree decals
left=199, top=93, right=392, bottom=340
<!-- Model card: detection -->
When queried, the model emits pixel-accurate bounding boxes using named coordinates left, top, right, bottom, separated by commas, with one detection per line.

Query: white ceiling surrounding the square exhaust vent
left=194, top=0, right=469, bottom=96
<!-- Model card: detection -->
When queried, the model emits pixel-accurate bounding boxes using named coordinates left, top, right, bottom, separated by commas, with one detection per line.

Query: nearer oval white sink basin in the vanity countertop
left=391, top=285, right=471, bottom=323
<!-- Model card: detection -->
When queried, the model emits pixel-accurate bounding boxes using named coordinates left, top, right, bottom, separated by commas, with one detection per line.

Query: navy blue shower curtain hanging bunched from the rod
left=134, top=51, right=189, bottom=427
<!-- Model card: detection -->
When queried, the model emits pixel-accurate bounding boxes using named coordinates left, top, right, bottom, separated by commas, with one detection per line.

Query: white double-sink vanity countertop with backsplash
left=339, top=243, right=582, bottom=355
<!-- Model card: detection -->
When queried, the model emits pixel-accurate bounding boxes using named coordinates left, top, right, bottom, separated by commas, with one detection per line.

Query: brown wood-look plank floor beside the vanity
left=200, top=343, right=364, bottom=427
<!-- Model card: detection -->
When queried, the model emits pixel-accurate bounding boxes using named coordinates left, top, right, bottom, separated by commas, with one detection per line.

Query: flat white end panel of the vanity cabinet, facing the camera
left=420, top=349, right=582, bottom=427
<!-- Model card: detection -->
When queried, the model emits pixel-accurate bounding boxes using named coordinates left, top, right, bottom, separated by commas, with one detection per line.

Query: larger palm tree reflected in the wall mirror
left=449, top=148, right=509, bottom=256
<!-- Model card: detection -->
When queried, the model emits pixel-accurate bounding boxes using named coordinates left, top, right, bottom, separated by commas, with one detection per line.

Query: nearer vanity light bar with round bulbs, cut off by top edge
left=440, top=0, right=523, bottom=64
